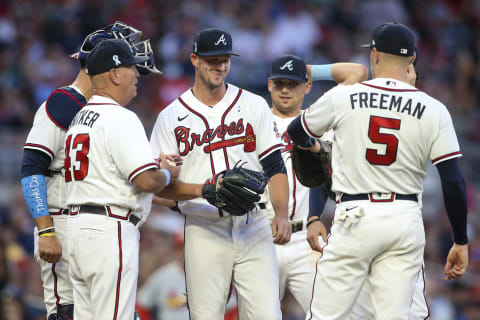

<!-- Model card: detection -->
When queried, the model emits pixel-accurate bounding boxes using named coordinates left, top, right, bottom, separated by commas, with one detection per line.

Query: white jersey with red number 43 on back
left=65, top=96, right=158, bottom=222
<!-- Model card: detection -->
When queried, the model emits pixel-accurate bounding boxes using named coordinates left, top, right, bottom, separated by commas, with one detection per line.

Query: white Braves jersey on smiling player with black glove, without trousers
left=150, top=84, right=282, bottom=216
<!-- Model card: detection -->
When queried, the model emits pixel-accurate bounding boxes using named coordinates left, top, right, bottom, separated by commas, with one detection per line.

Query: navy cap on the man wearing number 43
left=86, top=39, right=149, bottom=76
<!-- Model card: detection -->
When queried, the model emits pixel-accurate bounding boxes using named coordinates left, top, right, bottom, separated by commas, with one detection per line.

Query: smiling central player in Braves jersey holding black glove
left=150, top=28, right=291, bottom=320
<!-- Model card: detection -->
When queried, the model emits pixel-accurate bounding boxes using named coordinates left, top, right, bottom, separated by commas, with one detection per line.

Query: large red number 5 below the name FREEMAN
left=366, top=116, right=400, bottom=166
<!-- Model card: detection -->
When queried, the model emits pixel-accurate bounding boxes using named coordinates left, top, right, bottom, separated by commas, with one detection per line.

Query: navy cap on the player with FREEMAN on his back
left=362, top=22, right=415, bottom=57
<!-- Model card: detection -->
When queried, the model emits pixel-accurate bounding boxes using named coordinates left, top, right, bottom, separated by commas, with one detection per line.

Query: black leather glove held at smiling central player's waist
left=202, top=162, right=268, bottom=216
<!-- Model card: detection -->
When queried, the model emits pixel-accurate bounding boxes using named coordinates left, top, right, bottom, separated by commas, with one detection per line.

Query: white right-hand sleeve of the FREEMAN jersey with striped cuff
left=430, top=108, right=461, bottom=165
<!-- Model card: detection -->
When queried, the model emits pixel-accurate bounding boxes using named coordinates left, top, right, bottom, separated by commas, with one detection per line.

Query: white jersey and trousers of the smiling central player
left=151, top=84, right=282, bottom=320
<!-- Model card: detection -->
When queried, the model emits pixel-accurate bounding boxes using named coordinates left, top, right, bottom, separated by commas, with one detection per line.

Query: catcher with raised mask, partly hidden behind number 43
left=21, top=21, right=140, bottom=320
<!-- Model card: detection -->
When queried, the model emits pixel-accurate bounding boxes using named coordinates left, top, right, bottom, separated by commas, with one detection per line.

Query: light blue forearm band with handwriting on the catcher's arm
left=22, top=174, right=49, bottom=219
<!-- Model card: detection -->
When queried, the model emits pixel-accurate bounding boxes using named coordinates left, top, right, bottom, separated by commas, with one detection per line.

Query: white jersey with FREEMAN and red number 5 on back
left=302, top=78, right=461, bottom=194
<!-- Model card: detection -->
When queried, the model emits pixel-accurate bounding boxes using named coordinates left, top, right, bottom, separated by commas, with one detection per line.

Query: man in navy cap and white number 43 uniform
left=64, top=39, right=178, bottom=320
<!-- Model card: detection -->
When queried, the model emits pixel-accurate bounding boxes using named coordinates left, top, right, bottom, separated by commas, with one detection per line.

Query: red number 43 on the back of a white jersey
left=64, top=133, right=90, bottom=182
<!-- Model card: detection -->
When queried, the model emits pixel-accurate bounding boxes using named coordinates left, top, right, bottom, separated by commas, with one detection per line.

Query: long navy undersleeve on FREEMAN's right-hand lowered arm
left=437, top=158, right=468, bottom=244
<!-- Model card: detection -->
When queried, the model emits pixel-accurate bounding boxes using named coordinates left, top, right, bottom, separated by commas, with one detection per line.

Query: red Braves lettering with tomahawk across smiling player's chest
left=174, top=119, right=256, bottom=156
